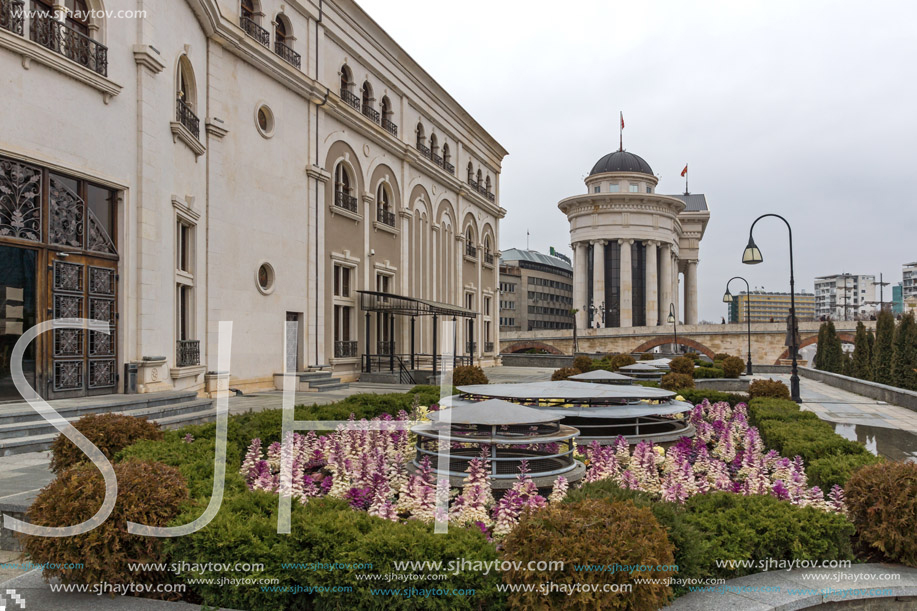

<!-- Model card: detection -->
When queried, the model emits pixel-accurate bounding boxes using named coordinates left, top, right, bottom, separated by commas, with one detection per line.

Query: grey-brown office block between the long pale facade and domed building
left=500, top=248, right=574, bottom=331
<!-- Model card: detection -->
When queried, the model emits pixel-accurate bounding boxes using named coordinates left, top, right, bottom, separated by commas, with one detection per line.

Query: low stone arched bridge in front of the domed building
left=500, top=321, right=864, bottom=365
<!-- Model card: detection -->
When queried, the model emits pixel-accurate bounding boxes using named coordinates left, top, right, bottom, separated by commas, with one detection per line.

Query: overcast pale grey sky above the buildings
left=358, top=0, right=917, bottom=322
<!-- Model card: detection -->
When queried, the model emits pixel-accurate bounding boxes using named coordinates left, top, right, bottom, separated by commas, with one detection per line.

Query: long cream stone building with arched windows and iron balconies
left=0, top=0, right=506, bottom=400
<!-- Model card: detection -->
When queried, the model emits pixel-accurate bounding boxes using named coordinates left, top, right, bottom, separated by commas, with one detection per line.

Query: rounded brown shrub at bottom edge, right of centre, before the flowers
left=503, top=499, right=674, bottom=611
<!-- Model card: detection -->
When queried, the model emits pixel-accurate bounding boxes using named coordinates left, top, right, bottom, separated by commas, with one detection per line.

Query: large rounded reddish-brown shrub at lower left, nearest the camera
left=20, top=461, right=188, bottom=599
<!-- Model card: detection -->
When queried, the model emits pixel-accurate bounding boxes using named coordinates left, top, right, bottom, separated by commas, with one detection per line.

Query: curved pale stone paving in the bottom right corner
left=665, top=564, right=917, bottom=611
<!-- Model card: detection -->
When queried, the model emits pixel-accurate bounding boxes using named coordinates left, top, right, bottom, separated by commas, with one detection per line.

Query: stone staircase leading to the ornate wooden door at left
left=0, top=391, right=216, bottom=456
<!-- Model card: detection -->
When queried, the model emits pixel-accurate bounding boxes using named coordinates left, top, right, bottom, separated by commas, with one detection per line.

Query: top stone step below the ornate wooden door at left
left=0, top=391, right=197, bottom=425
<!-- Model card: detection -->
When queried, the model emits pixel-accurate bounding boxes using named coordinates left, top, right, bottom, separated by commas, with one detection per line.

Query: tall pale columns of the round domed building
left=573, top=239, right=697, bottom=329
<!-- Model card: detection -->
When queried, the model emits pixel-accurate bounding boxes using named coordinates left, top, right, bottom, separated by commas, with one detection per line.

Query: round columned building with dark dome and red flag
left=558, top=150, right=710, bottom=329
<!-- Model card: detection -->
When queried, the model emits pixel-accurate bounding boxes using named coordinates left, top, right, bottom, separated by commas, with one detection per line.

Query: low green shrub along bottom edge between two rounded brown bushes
left=167, top=498, right=504, bottom=611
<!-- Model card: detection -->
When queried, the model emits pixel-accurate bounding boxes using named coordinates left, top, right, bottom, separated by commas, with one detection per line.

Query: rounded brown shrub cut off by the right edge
left=845, top=462, right=917, bottom=566
